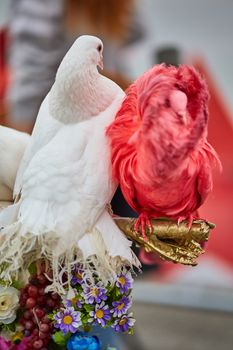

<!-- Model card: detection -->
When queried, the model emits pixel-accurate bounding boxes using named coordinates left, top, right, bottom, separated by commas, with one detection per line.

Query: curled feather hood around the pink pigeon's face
left=107, top=64, right=209, bottom=185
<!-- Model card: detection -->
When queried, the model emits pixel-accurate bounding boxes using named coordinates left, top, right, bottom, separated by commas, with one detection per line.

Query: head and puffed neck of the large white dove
left=49, top=35, right=122, bottom=122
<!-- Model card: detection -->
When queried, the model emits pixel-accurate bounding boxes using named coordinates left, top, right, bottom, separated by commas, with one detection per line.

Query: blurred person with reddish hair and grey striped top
left=8, top=0, right=142, bottom=132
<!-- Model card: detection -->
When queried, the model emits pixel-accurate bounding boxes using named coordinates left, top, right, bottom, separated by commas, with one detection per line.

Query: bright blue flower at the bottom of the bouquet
left=66, top=332, right=101, bottom=350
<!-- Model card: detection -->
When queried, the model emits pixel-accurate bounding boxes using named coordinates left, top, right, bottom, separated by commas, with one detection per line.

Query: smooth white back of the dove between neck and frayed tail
left=19, top=122, right=113, bottom=239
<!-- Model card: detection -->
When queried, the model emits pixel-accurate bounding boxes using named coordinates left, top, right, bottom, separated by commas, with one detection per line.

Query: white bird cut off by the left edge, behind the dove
left=0, top=125, right=30, bottom=201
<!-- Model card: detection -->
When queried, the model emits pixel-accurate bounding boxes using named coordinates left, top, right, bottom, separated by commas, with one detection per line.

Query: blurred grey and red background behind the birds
left=0, top=0, right=233, bottom=350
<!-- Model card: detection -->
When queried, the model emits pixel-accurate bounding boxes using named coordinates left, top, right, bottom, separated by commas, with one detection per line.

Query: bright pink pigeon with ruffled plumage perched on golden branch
left=107, top=64, right=220, bottom=227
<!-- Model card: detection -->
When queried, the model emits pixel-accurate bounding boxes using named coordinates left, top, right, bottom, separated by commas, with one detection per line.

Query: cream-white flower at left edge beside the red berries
left=0, top=286, right=19, bottom=324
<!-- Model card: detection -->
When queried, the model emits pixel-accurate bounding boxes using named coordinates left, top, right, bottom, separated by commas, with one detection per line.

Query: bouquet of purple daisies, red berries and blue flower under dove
left=0, top=263, right=135, bottom=350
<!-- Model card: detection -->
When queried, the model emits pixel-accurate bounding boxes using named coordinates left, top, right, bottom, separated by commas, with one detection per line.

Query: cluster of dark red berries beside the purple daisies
left=20, top=274, right=60, bottom=350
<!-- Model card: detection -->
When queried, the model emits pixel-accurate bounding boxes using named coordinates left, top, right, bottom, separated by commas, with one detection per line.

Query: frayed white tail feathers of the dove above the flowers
left=0, top=203, right=140, bottom=294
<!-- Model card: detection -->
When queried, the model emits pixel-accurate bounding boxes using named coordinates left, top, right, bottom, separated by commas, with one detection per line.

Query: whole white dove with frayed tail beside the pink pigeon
left=0, top=36, right=139, bottom=293
